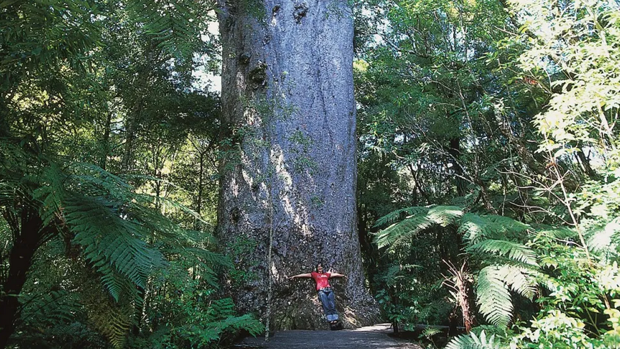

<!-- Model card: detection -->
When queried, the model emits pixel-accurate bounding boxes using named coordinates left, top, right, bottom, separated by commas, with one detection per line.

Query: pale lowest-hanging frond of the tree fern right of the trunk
left=476, top=265, right=513, bottom=326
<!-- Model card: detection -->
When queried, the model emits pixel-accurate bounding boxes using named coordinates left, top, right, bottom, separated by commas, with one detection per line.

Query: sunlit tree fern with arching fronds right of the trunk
left=376, top=206, right=539, bottom=326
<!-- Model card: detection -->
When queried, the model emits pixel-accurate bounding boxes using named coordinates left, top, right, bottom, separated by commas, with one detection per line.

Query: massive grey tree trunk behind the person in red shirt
left=218, top=0, right=378, bottom=329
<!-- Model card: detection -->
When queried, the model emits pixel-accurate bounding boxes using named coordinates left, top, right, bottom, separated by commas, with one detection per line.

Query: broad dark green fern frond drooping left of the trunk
left=35, top=164, right=168, bottom=301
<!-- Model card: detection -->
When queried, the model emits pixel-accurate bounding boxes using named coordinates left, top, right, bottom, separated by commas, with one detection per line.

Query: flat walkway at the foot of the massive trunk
left=233, top=324, right=422, bottom=349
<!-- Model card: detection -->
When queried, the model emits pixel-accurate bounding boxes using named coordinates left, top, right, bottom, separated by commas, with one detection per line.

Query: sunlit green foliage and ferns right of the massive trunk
left=358, top=0, right=620, bottom=349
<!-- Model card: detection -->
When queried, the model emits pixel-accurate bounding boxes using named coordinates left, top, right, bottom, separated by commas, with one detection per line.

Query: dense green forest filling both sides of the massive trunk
left=0, top=0, right=620, bottom=348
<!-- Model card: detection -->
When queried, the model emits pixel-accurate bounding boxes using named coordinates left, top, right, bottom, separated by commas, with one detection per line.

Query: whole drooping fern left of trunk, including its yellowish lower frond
left=23, top=163, right=234, bottom=347
